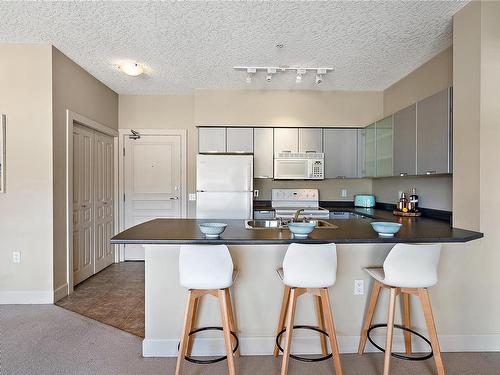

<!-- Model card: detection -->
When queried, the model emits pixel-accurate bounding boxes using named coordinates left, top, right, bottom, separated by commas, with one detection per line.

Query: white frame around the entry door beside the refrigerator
left=115, top=128, right=187, bottom=262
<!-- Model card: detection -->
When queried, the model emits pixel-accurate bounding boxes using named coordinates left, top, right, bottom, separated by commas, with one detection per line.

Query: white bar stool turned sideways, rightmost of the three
left=358, top=244, right=444, bottom=375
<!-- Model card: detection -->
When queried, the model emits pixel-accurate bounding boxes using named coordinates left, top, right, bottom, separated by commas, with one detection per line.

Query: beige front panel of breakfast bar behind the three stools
left=143, top=244, right=432, bottom=357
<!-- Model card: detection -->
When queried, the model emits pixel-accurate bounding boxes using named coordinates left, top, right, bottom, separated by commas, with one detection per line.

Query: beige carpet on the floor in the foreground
left=0, top=305, right=500, bottom=375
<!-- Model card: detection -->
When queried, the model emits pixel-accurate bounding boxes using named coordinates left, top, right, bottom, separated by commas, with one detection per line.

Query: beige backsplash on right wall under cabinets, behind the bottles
left=372, top=175, right=453, bottom=211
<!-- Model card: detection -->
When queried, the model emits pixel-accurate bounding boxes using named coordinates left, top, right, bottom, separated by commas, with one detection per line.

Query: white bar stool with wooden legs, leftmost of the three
left=175, top=245, right=239, bottom=375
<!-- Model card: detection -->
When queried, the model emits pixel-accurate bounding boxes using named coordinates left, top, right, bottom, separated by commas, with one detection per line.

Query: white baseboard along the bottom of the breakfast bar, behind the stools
left=142, top=335, right=500, bottom=357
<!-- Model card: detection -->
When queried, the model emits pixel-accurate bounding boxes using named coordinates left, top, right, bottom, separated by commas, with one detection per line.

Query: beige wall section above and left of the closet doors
left=52, top=47, right=118, bottom=289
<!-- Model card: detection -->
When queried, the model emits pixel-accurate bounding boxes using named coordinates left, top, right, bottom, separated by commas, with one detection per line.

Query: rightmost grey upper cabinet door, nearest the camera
left=417, top=89, right=451, bottom=175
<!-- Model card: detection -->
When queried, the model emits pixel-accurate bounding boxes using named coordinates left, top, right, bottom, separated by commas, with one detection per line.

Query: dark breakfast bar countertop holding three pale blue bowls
left=111, top=208, right=483, bottom=245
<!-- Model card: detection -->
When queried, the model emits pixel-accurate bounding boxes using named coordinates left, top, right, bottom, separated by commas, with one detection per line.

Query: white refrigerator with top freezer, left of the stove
left=196, top=154, right=253, bottom=219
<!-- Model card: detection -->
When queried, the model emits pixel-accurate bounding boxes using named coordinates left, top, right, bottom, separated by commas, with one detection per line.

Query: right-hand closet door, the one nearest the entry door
left=94, top=132, right=114, bottom=273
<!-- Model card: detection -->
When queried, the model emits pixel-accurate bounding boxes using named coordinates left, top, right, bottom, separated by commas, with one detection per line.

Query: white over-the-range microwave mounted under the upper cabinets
left=274, top=152, right=325, bottom=180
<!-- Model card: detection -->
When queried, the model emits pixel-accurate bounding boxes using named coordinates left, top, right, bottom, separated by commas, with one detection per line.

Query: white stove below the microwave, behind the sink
left=271, top=189, right=330, bottom=219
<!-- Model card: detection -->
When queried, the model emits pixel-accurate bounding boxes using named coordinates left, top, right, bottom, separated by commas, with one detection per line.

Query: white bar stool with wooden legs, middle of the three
left=273, top=243, right=342, bottom=375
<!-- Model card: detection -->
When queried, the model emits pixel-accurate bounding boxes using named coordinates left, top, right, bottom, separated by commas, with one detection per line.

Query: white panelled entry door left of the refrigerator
left=123, top=134, right=183, bottom=260
